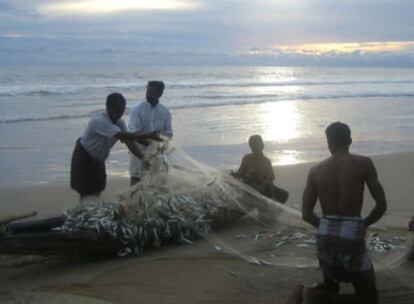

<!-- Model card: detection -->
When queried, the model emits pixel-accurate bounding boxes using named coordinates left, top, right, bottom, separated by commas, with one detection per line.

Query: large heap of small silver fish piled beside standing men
left=62, top=140, right=243, bottom=256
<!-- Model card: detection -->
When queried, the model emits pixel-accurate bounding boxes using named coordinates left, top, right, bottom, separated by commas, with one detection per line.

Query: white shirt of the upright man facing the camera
left=128, top=100, right=173, bottom=177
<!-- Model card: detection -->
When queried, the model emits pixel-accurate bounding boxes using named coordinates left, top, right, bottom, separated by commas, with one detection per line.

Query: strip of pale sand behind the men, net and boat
left=0, top=152, right=414, bottom=227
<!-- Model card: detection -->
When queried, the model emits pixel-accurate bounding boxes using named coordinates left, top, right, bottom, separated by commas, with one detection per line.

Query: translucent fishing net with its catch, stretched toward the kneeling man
left=63, top=140, right=412, bottom=276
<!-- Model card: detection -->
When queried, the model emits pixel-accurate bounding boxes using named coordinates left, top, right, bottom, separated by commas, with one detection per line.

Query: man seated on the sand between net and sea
left=231, top=135, right=289, bottom=203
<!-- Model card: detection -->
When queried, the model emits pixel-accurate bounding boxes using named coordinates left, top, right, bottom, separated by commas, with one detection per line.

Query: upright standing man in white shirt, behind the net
left=128, top=81, right=173, bottom=186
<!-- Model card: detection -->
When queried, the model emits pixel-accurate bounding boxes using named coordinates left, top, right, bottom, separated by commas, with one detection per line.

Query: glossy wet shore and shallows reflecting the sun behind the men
left=0, top=92, right=414, bottom=187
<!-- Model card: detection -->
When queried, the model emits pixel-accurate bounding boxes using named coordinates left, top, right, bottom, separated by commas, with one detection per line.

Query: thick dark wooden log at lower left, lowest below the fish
left=0, top=231, right=121, bottom=257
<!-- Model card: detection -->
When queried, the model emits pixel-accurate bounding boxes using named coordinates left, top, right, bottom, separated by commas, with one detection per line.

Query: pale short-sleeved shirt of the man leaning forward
left=81, top=111, right=126, bottom=162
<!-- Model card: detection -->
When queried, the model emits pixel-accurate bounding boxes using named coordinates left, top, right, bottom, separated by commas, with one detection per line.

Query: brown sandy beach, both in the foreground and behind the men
left=0, top=152, right=414, bottom=304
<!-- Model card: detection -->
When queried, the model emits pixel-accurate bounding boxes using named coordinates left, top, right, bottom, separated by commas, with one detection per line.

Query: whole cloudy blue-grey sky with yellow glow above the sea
left=0, top=0, right=414, bottom=67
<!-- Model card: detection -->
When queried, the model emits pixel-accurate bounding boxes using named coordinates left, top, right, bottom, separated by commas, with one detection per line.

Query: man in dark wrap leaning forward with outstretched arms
left=70, top=93, right=161, bottom=198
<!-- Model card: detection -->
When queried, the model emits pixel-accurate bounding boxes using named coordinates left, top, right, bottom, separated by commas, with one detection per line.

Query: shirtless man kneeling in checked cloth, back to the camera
left=288, top=122, right=387, bottom=304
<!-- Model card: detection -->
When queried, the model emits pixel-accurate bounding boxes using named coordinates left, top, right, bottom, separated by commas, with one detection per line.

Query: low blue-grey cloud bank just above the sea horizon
left=0, top=35, right=414, bottom=67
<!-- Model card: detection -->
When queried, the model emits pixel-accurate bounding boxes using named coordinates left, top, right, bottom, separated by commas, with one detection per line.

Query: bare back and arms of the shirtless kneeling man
left=302, top=148, right=386, bottom=227
